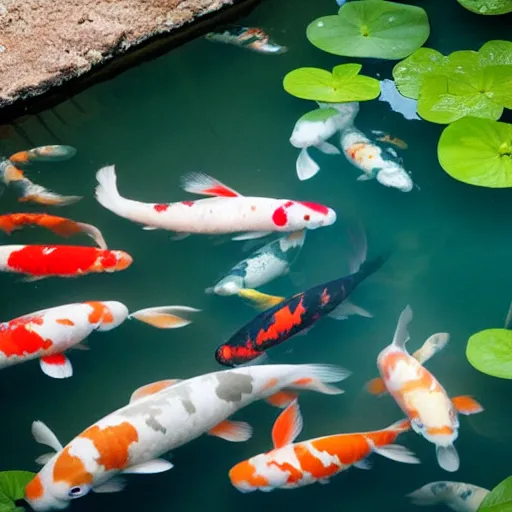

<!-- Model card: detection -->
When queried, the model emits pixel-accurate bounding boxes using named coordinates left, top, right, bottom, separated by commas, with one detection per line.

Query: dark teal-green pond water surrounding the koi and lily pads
left=0, top=0, right=512, bottom=512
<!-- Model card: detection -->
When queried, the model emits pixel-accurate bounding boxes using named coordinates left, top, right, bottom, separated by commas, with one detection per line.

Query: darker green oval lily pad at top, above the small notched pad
left=306, top=0, right=430, bottom=59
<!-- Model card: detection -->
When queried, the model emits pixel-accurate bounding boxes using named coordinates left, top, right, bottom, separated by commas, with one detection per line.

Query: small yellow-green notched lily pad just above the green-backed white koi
left=283, top=63, right=380, bottom=103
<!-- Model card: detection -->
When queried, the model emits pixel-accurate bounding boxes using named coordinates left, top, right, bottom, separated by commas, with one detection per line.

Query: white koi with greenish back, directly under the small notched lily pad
left=290, top=102, right=359, bottom=181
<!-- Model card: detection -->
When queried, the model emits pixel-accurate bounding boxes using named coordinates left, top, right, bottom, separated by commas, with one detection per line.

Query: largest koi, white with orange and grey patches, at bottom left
left=25, top=365, right=349, bottom=512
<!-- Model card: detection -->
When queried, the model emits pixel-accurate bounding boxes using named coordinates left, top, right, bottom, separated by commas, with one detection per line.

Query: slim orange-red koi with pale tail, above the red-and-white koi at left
left=0, top=213, right=107, bottom=249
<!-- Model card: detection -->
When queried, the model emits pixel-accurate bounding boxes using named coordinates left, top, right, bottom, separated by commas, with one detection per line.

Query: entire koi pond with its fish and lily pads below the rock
left=0, top=0, right=512, bottom=512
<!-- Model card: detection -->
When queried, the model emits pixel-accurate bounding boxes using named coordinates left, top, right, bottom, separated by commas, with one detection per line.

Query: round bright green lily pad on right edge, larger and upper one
left=437, top=117, right=512, bottom=187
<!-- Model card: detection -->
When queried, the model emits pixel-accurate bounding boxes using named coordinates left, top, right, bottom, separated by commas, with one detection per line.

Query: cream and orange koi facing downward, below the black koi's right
left=377, top=306, right=483, bottom=471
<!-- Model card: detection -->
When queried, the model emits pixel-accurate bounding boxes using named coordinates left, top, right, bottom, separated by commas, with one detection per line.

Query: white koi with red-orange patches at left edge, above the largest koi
left=0, top=301, right=199, bottom=379
